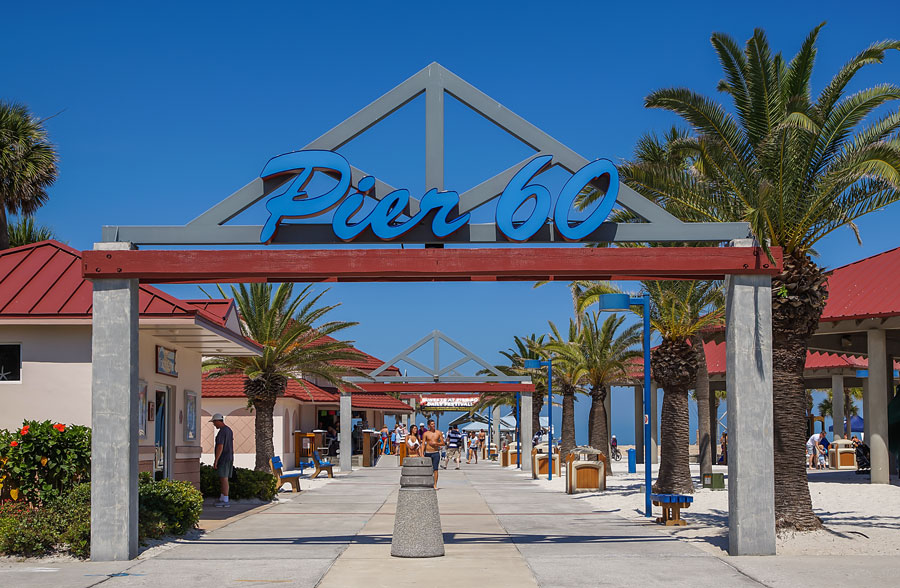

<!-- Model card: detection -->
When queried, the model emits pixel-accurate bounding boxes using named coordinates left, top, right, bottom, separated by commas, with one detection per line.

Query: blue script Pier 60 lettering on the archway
left=259, top=150, right=619, bottom=243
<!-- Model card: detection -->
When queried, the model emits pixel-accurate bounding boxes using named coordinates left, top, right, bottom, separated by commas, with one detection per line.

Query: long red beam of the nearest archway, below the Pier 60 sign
left=82, top=247, right=781, bottom=284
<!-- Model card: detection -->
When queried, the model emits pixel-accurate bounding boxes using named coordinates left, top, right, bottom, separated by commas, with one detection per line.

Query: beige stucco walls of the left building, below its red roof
left=0, top=324, right=202, bottom=482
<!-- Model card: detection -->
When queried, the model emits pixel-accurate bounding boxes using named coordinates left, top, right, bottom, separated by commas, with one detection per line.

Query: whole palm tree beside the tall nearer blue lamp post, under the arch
left=581, top=281, right=722, bottom=493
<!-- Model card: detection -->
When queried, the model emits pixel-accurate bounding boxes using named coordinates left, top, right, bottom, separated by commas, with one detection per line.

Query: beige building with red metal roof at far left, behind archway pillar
left=0, top=241, right=259, bottom=484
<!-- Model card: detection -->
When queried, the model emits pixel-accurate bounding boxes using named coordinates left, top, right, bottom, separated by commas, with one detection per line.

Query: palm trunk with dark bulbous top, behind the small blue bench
left=651, top=339, right=697, bottom=494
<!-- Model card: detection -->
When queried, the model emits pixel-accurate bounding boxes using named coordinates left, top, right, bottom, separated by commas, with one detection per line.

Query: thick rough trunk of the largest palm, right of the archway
left=772, top=255, right=828, bottom=531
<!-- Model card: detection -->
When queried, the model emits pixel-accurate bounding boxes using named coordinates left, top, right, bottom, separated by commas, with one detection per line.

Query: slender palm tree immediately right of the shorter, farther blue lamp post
left=545, top=319, right=584, bottom=460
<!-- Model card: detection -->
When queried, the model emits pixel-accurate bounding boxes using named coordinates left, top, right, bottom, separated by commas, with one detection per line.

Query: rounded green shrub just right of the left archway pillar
left=138, top=477, right=203, bottom=539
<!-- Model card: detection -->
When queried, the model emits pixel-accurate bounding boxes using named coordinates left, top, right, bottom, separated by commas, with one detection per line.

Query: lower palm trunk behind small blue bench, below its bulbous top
left=653, top=386, right=694, bottom=494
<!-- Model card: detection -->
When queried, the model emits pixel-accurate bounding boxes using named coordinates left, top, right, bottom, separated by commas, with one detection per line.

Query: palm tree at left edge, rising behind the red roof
left=0, top=101, right=57, bottom=250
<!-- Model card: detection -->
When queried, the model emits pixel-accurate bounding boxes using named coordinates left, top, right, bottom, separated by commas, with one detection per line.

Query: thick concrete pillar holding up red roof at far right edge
left=865, top=329, right=894, bottom=484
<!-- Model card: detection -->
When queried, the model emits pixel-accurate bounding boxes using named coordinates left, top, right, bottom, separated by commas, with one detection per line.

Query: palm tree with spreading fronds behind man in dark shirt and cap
left=203, top=284, right=364, bottom=471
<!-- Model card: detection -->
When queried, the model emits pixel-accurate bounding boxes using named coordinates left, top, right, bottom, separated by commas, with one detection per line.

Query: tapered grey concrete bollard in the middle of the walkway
left=391, top=457, right=444, bottom=557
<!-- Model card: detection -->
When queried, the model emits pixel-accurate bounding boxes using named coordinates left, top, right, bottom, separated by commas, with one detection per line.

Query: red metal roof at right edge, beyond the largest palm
left=820, top=247, right=900, bottom=322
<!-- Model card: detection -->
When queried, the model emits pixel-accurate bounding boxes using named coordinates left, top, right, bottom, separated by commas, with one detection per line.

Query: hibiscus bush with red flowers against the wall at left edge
left=0, top=421, right=91, bottom=506
